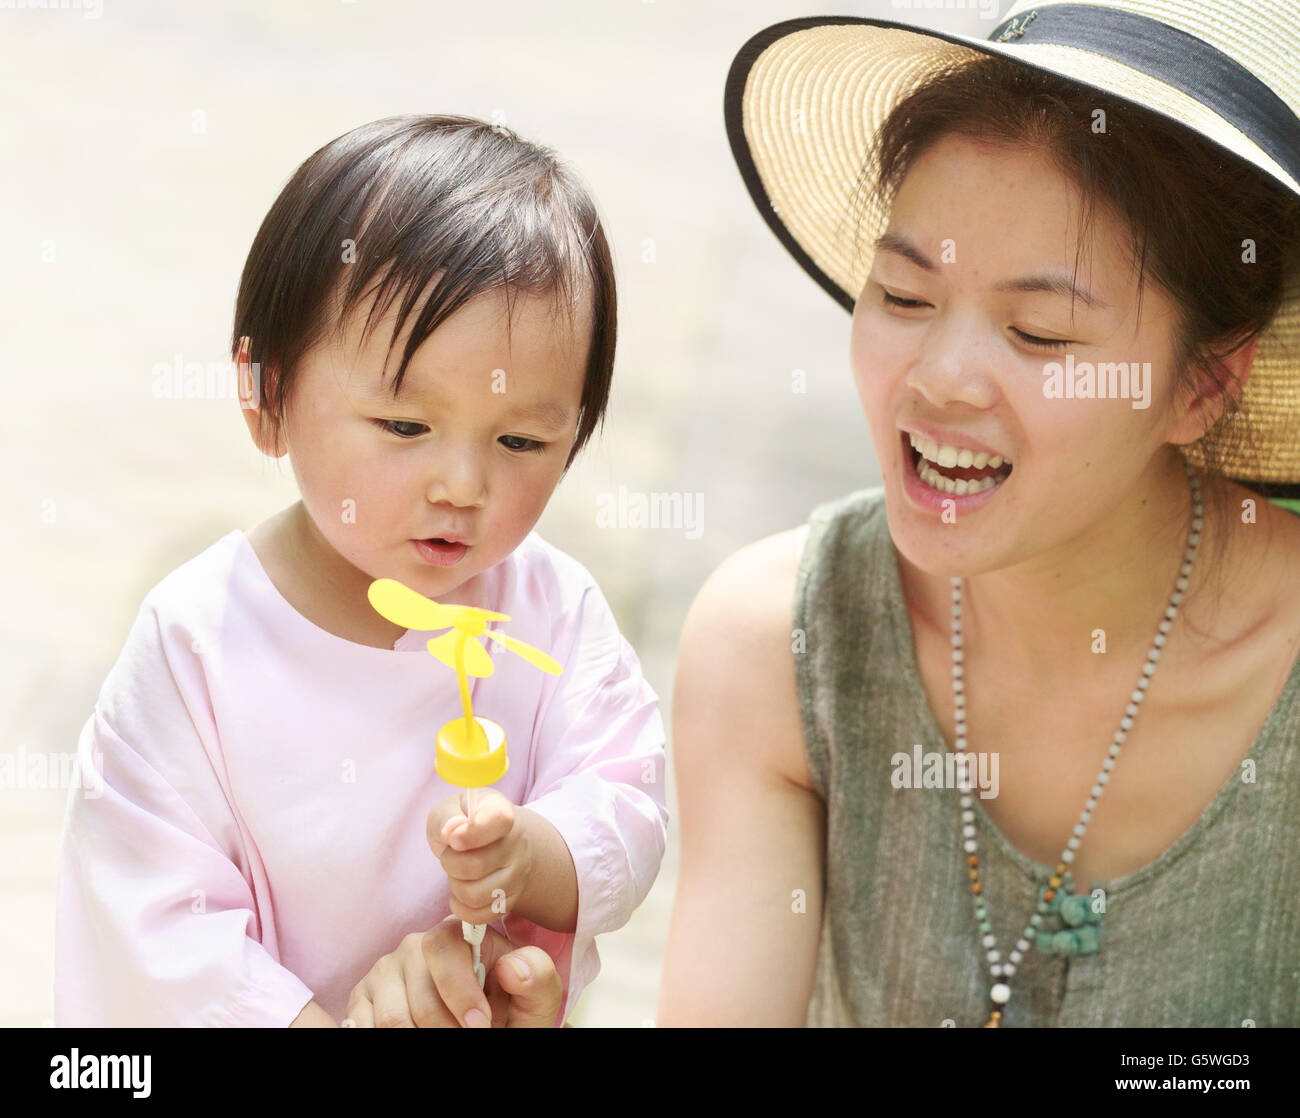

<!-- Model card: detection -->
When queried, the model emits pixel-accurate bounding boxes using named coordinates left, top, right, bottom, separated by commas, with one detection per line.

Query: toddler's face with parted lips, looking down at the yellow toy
left=253, top=283, right=592, bottom=605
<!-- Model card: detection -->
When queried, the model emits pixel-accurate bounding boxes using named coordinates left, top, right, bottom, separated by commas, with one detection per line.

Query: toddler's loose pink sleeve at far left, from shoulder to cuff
left=53, top=602, right=312, bottom=1027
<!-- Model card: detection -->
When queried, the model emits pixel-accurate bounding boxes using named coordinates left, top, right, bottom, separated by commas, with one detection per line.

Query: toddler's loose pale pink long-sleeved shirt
left=53, top=530, right=668, bottom=1027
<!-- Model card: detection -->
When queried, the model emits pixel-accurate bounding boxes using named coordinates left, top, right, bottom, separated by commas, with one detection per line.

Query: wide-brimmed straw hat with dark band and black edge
left=724, top=0, right=1300, bottom=498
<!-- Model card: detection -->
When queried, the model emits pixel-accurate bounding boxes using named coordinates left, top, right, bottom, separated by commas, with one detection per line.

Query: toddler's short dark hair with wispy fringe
left=230, top=114, right=618, bottom=472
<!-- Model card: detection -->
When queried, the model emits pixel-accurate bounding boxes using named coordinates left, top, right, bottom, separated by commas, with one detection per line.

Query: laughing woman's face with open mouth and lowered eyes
left=852, top=137, right=1193, bottom=575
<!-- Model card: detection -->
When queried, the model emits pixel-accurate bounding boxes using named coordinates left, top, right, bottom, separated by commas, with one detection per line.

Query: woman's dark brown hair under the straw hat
left=852, top=56, right=1300, bottom=629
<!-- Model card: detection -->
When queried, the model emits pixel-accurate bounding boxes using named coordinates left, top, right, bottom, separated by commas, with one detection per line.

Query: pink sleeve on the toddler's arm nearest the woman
left=503, top=584, right=668, bottom=1024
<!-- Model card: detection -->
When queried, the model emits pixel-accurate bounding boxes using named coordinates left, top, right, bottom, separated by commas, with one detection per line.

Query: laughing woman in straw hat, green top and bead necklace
left=658, top=0, right=1300, bottom=1027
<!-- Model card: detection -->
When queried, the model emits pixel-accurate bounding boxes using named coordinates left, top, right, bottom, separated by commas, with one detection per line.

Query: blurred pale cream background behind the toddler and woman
left=0, top=0, right=987, bottom=1026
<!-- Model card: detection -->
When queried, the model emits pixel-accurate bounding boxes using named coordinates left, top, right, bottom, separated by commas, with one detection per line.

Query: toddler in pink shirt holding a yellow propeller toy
left=53, top=116, right=667, bottom=1027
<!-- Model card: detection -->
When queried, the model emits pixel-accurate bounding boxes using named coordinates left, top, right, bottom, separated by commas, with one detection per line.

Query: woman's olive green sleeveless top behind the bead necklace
left=794, top=489, right=1300, bottom=1027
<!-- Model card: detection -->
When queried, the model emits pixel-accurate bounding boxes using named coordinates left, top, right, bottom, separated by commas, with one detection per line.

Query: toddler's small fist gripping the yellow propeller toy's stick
left=425, top=788, right=533, bottom=924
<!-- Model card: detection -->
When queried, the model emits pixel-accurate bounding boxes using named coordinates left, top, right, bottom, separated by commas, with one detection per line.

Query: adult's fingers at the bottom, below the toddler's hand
left=343, top=917, right=564, bottom=1028
